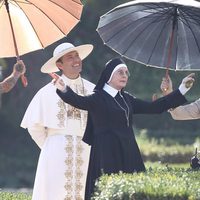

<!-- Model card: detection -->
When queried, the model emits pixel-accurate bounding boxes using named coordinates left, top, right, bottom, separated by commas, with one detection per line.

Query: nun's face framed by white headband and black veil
left=108, top=67, right=129, bottom=90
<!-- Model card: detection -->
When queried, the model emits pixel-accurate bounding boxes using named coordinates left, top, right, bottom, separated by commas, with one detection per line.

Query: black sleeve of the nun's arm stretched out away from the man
left=132, top=89, right=187, bottom=114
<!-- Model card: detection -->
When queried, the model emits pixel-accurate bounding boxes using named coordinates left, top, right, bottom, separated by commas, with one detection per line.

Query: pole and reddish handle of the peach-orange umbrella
left=5, top=0, right=28, bottom=87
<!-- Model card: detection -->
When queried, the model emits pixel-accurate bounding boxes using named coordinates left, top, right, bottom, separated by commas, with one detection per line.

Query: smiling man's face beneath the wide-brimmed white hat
left=56, top=51, right=82, bottom=79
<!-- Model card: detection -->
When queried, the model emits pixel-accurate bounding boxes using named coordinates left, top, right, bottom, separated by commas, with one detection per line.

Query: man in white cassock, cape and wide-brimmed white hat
left=21, top=43, right=94, bottom=200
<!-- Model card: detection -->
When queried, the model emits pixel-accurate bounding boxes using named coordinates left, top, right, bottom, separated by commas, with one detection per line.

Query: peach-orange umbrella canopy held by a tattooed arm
left=0, top=0, right=83, bottom=57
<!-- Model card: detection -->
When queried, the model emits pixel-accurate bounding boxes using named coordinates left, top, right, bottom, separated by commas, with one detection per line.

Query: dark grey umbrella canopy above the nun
left=97, top=0, right=200, bottom=70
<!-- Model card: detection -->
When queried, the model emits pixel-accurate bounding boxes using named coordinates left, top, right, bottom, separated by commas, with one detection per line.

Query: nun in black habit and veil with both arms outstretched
left=54, top=58, right=194, bottom=200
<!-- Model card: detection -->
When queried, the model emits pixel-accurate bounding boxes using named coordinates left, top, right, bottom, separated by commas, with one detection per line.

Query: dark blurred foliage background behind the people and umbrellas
left=0, top=0, right=200, bottom=188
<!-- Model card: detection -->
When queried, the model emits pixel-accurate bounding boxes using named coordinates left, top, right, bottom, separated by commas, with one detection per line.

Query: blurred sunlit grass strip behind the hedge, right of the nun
left=137, top=130, right=200, bottom=163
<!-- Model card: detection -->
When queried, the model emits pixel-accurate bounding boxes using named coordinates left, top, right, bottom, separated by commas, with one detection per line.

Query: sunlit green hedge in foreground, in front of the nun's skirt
left=92, top=167, right=200, bottom=200
